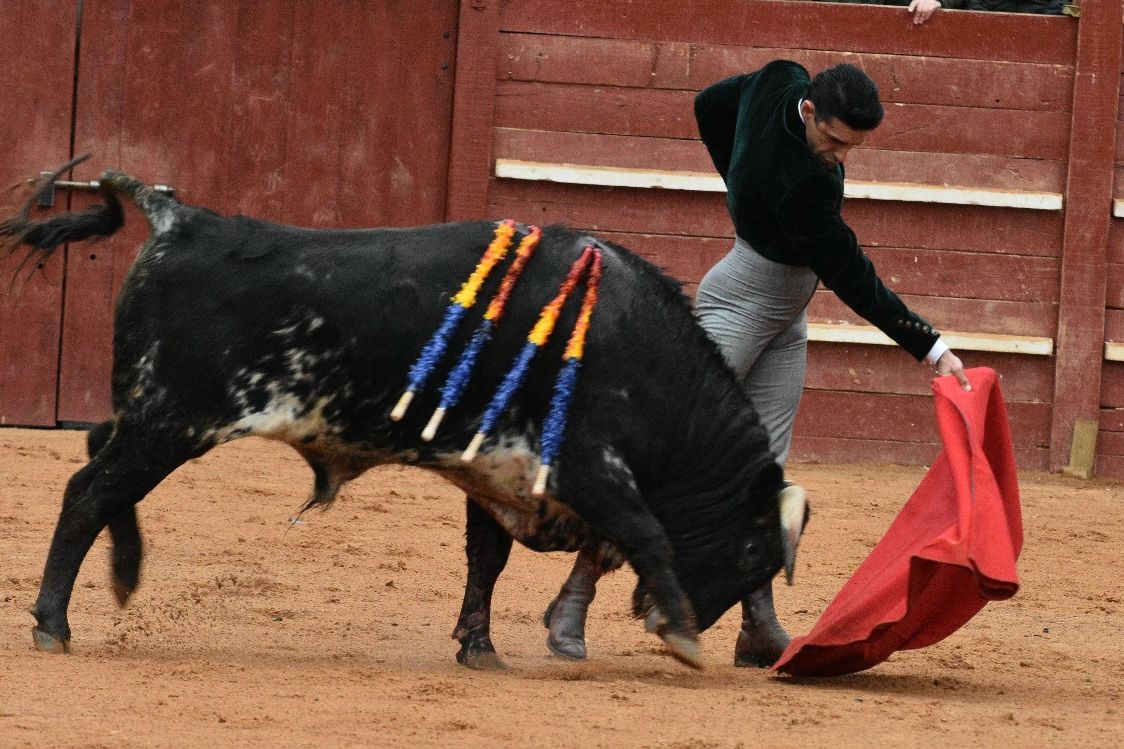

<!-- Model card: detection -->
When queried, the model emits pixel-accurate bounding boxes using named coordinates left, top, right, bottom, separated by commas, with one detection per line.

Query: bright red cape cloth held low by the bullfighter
left=773, top=368, right=1023, bottom=676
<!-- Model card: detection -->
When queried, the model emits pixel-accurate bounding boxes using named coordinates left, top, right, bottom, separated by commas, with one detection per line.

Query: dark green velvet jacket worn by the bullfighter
left=695, top=60, right=940, bottom=360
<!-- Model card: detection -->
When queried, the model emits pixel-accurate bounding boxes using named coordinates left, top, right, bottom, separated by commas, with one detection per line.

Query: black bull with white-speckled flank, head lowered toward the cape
left=0, top=166, right=804, bottom=667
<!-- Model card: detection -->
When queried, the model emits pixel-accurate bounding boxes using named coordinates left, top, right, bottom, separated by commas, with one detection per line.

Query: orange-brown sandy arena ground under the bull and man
left=0, top=428, right=1124, bottom=749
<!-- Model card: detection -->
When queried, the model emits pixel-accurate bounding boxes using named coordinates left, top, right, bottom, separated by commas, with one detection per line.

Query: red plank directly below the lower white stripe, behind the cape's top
left=805, top=342, right=1053, bottom=401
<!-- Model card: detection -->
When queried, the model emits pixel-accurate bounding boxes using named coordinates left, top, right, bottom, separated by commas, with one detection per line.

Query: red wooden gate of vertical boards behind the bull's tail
left=0, top=0, right=457, bottom=425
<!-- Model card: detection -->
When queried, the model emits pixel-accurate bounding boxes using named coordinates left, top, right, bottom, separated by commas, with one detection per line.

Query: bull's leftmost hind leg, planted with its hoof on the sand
left=31, top=427, right=191, bottom=652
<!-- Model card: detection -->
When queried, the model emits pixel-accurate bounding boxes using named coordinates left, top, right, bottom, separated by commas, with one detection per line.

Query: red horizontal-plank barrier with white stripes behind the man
left=448, top=0, right=1124, bottom=469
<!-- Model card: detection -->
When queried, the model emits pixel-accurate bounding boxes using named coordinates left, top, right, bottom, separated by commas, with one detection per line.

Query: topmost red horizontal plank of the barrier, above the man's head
left=502, top=0, right=1077, bottom=64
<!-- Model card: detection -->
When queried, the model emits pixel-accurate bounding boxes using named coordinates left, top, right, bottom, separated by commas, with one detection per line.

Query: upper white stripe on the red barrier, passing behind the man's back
left=496, top=159, right=1062, bottom=210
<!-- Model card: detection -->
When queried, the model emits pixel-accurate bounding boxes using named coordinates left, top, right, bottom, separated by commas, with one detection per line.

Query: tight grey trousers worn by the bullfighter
left=695, top=237, right=818, bottom=466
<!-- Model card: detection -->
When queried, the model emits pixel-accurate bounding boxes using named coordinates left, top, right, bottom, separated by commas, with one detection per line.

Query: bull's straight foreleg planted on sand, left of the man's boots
left=453, top=497, right=511, bottom=670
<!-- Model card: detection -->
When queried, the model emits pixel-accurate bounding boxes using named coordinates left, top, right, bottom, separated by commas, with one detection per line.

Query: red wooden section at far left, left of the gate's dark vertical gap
left=0, top=1, right=76, bottom=426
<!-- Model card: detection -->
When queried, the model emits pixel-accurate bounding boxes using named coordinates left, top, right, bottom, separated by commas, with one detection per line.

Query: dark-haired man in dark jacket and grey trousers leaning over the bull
left=544, top=60, right=971, bottom=666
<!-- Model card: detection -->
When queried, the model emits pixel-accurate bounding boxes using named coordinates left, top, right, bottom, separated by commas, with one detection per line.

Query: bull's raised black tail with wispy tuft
left=0, top=155, right=180, bottom=277
